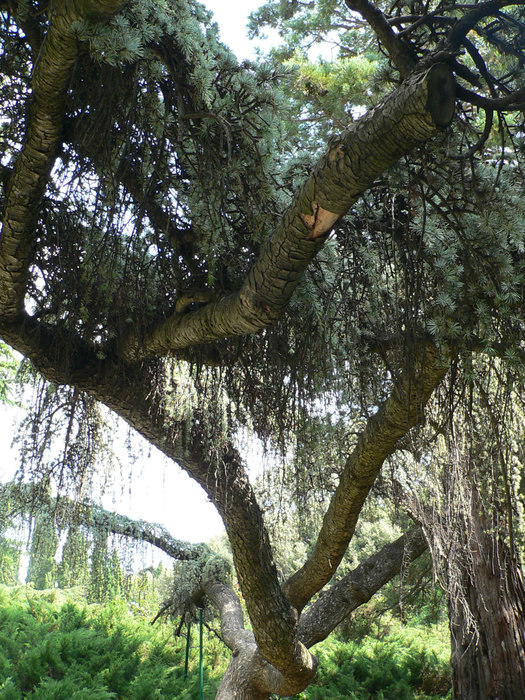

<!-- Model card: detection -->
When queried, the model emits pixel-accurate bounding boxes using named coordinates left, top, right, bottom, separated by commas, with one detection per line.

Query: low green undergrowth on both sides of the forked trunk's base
left=0, top=586, right=450, bottom=700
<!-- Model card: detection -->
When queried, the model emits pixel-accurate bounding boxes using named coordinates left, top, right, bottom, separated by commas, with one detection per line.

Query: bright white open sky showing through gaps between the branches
left=0, top=0, right=272, bottom=542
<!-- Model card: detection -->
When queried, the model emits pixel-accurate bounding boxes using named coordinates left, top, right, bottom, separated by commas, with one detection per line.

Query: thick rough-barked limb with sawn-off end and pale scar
left=119, top=63, right=455, bottom=361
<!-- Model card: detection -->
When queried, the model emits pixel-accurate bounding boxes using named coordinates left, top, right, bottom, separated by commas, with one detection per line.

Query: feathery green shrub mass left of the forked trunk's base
left=0, top=587, right=225, bottom=700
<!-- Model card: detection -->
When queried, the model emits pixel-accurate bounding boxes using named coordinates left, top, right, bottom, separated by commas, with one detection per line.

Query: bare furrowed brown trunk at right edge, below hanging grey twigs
left=449, top=508, right=525, bottom=700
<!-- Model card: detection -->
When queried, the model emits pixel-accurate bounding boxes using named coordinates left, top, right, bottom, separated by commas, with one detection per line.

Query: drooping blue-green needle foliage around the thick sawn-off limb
left=1, top=0, right=524, bottom=460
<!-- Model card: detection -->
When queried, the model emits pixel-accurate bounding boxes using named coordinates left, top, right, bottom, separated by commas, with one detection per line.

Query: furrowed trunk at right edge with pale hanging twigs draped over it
left=406, top=360, right=525, bottom=700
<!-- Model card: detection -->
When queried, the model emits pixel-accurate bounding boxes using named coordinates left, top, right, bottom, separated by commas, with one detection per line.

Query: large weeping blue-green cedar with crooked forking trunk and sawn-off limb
left=0, top=0, right=525, bottom=698
